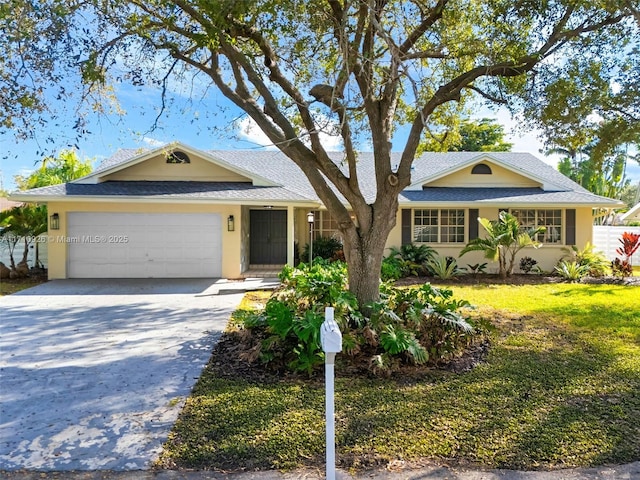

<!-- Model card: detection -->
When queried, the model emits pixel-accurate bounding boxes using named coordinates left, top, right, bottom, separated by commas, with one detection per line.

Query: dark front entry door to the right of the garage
left=249, top=210, right=287, bottom=265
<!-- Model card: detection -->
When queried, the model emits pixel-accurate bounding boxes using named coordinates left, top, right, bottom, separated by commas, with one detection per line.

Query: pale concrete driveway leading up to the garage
left=0, top=279, right=272, bottom=471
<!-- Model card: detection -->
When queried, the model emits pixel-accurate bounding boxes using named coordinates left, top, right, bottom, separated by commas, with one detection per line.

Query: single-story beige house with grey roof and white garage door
left=12, top=143, right=621, bottom=279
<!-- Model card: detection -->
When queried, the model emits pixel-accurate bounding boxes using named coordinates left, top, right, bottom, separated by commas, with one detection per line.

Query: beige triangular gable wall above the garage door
left=103, top=155, right=250, bottom=182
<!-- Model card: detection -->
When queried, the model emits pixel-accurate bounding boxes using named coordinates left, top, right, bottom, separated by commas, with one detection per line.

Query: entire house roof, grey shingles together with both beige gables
left=12, top=143, right=621, bottom=207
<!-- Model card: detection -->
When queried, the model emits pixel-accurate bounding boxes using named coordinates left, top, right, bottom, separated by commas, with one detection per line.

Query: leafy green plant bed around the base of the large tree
left=243, top=260, right=487, bottom=375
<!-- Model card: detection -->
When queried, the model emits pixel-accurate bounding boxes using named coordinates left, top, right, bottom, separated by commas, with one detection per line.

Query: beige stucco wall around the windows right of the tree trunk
left=386, top=206, right=593, bottom=272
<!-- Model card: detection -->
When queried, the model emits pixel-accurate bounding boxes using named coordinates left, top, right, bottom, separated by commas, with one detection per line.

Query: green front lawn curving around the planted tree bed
left=159, top=284, right=640, bottom=470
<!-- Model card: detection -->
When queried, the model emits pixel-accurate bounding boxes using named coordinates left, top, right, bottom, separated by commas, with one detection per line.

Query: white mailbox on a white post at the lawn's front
left=320, top=307, right=342, bottom=480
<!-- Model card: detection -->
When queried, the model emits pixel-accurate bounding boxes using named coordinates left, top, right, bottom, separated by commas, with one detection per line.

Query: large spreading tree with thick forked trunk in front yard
left=0, top=0, right=640, bottom=304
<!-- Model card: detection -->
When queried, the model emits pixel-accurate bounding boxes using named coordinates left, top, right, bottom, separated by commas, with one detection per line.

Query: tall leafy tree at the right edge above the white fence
left=525, top=37, right=640, bottom=202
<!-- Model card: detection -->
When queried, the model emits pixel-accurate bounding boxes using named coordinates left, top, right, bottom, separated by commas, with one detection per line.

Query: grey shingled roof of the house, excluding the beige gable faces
left=13, top=147, right=618, bottom=206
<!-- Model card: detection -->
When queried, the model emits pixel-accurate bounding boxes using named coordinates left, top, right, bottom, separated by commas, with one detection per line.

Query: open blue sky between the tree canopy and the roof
left=0, top=82, right=640, bottom=190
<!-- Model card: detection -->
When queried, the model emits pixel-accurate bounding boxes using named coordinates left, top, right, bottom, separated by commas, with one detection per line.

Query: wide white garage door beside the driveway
left=67, top=212, right=222, bottom=278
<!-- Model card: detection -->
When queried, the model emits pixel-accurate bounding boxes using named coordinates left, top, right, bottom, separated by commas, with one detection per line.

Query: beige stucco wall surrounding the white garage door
left=48, top=202, right=242, bottom=279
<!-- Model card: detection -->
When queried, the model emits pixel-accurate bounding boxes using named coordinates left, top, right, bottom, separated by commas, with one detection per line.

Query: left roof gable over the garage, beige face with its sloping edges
left=73, top=143, right=278, bottom=186
